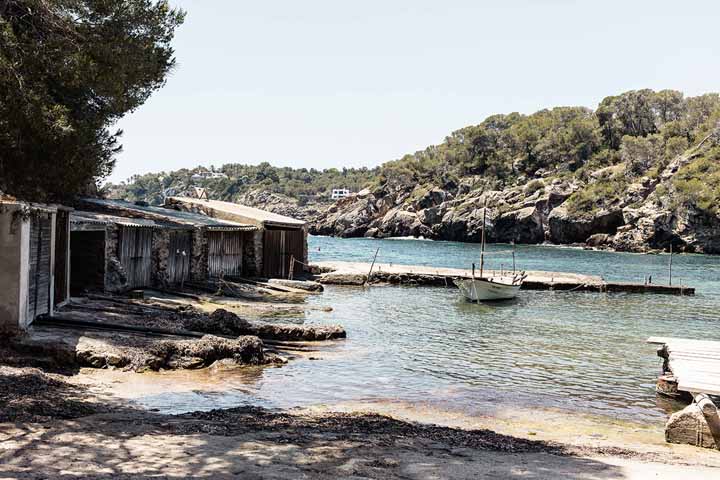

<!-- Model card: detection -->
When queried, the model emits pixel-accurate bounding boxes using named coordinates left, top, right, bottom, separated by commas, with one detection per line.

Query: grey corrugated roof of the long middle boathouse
left=82, top=198, right=257, bottom=231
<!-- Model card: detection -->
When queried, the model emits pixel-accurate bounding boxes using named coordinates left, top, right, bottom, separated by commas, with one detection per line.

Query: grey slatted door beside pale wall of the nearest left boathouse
left=28, top=213, right=52, bottom=321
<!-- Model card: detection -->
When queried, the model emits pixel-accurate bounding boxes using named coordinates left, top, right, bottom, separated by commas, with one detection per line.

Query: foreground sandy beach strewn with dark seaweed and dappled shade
left=0, top=357, right=720, bottom=479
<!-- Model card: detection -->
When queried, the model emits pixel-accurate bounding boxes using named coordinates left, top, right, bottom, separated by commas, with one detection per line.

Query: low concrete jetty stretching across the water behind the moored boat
left=311, top=261, right=695, bottom=295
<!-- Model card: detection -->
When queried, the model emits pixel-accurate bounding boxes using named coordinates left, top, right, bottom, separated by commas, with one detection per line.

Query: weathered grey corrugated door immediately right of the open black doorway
left=118, top=227, right=152, bottom=288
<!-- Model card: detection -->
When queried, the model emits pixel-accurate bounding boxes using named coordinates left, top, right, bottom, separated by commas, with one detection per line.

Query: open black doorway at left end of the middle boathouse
left=70, top=231, right=105, bottom=296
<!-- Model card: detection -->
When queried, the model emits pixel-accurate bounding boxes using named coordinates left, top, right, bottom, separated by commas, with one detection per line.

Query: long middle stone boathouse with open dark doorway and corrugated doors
left=72, top=199, right=257, bottom=293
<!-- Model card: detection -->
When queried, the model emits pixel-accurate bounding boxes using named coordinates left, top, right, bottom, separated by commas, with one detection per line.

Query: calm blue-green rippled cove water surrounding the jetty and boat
left=135, top=237, right=720, bottom=421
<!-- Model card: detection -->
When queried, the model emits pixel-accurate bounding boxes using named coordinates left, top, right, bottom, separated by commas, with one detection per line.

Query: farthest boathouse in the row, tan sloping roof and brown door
left=165, top=197, right=308, bottom=278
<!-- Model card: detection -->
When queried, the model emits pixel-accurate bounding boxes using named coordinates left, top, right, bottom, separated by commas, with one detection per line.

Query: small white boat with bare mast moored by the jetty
left=455, top=204, right=526, bottom=302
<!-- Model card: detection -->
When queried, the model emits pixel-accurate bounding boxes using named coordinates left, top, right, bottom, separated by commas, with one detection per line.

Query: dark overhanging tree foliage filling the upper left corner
left=0, top=0, right=184, bottom=200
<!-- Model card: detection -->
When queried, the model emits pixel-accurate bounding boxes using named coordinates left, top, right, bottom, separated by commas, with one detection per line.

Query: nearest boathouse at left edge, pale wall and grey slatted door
left=0, top=200, right=72, bottom=331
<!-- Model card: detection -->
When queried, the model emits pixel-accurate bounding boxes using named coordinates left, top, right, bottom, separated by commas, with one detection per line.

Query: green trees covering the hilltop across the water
left=114, top=90, right=720, bottom=211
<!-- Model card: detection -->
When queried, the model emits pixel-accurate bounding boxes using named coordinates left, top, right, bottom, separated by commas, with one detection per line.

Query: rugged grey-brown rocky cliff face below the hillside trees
left=306, top=132, right=720, bottom=253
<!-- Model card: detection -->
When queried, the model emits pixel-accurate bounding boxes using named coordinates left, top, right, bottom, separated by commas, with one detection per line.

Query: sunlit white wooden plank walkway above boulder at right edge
left=647, top=337, right=720, bottom=395
